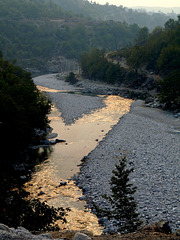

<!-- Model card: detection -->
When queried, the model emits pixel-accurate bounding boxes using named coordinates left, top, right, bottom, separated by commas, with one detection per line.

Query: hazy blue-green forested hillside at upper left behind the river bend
left=0, top=0, right=139, bottom=72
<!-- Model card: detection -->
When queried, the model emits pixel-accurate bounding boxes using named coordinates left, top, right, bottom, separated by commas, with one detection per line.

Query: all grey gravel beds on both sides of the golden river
left=34, top=75, right=180, bottom=231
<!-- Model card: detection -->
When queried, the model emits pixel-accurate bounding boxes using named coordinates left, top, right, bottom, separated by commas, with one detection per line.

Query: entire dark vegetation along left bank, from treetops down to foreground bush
left=0, top=54, right=70, bottom=231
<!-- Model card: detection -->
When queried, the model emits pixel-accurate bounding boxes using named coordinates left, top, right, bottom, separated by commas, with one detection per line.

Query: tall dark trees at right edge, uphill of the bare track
left=125, top=19, right=180, bottom=74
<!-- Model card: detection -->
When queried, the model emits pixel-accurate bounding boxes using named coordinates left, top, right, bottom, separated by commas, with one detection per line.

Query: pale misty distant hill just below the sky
left=50, top=0, right=176, bottom=30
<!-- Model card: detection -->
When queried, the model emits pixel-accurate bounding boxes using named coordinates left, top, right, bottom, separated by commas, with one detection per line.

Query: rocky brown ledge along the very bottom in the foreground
left=0, top=222, right=180, bottom=240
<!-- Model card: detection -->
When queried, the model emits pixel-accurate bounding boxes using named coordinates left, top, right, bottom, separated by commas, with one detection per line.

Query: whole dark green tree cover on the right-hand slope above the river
left=81, top=16, right=180, bottom=110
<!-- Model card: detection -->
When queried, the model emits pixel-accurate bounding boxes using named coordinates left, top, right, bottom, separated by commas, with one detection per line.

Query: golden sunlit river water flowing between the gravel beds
left=25, top=87, right=133, bottom=235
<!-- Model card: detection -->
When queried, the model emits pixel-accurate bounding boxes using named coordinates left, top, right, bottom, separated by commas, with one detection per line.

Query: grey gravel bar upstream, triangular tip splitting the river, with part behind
left=34, top=74, right=105, bottom=125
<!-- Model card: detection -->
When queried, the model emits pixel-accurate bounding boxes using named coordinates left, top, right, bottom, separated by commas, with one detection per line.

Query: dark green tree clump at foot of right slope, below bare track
left=80, top=48, right=148, bottom=89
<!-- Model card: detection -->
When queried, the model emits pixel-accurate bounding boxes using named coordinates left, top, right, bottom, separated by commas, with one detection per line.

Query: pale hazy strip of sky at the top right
left=93, top=0, right=180, bottom=7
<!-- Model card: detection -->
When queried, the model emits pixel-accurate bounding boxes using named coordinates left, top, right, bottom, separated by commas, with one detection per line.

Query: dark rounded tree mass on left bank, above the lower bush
left=0, top=58, right=51, bottom=163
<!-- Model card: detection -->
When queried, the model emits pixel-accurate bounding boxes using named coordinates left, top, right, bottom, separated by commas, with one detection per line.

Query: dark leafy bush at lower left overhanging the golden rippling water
left=0, top=186, right=69, bottom=231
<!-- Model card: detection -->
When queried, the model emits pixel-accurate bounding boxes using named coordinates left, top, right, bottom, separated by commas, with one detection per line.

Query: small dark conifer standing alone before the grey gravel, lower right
left=105, top=157, right=141, bottom=233
